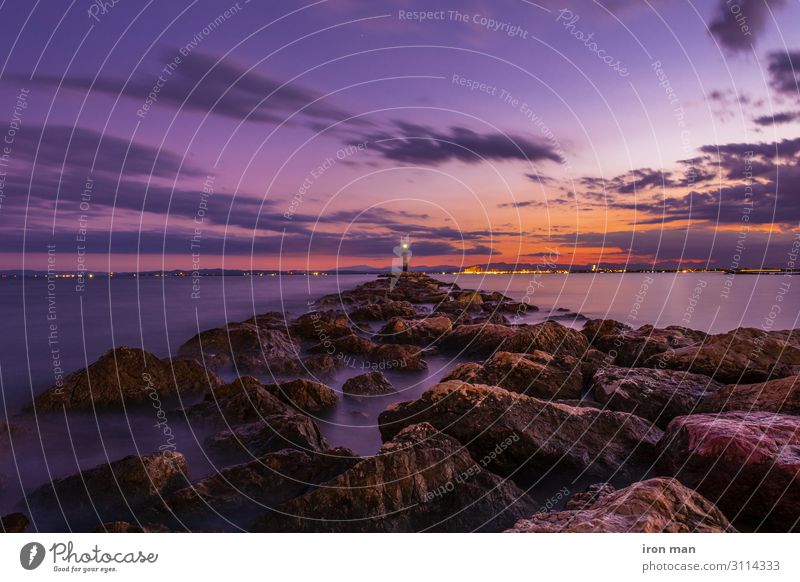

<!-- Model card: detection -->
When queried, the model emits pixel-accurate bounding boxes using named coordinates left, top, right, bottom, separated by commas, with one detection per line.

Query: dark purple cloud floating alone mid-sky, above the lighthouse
left=356, top=122, right=563, bottom=165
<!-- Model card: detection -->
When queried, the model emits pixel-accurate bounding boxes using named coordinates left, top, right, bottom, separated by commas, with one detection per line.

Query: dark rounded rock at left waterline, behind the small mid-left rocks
left=178, top=320, right=302, bottom=374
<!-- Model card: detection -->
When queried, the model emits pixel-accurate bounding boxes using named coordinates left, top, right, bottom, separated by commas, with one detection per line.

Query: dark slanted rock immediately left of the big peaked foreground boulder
left=167, top=448, right=359, bottom=529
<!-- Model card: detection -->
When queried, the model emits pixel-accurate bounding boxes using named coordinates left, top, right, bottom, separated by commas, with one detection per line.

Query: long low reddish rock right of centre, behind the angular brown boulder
left=442, top=321, right=589, bottom=357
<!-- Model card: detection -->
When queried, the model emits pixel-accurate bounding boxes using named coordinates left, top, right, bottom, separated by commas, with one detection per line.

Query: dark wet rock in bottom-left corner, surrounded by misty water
left=27, top=450, right=189, bottom=529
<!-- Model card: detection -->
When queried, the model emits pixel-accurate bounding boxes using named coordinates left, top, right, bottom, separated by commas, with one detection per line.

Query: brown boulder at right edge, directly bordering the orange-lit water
left=644, top=327, right=800, bottom=384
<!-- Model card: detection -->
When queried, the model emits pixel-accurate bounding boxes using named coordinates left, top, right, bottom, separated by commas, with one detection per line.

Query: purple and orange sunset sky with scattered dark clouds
left=0, top=0, right=800, bottom=271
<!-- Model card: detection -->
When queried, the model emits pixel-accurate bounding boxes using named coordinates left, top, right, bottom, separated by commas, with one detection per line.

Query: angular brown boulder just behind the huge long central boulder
left=442, top=351, right=583, bottom=399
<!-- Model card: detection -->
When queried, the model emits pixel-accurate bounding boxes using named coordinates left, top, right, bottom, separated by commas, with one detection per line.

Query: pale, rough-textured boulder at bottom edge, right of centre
left=508, top=477, right=736, bottom=533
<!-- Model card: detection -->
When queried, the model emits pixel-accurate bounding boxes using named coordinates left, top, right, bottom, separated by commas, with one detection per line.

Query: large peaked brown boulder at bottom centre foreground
left=253, top=424, right=531, bottom=532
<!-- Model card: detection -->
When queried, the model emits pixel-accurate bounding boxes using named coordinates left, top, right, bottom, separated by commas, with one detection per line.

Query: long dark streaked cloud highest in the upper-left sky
left=21, top=49, right=360, bottom=123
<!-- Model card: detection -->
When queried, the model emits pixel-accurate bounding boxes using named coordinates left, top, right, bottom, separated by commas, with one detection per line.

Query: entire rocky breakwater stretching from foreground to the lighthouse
left=17, top=274, right=800, bottom=532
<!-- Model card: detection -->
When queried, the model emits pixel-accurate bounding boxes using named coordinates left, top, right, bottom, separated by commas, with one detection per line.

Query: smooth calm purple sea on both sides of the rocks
left=0, top=273, right=800, bottom=511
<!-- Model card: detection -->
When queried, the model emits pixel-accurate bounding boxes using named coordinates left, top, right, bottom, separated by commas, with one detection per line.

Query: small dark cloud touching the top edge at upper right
left=708, top=0, right=786, bottom=52
